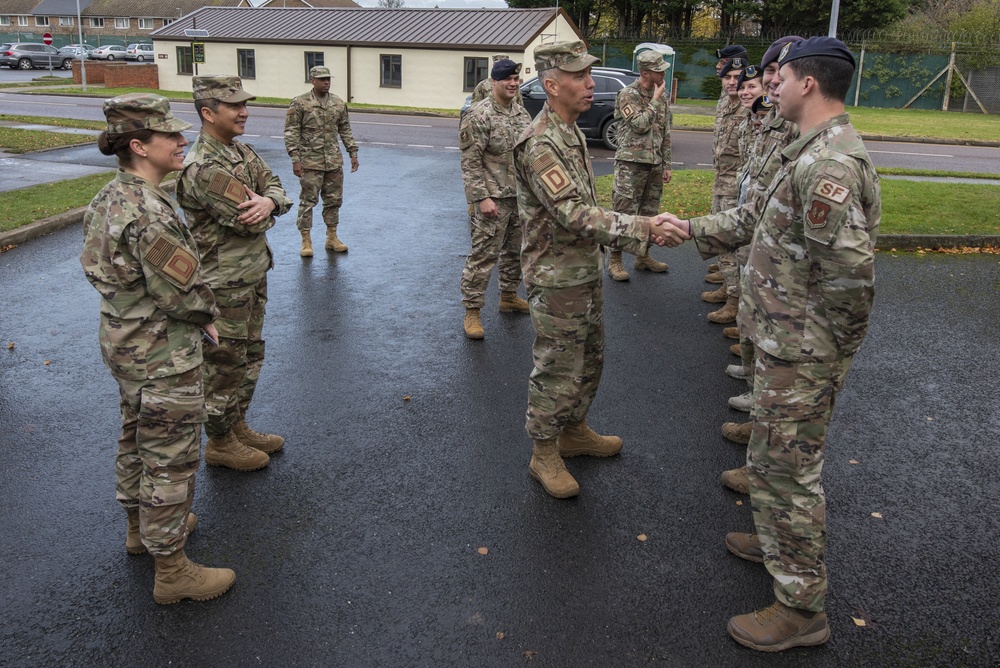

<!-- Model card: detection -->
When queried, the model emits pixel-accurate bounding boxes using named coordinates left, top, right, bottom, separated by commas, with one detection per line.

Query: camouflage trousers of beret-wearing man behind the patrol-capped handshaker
left=462, top=197, right=521, bottom=308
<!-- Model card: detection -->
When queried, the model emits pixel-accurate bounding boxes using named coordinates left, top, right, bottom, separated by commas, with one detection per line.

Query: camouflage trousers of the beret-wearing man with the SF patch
left=747, top=348, right=851, bottom=610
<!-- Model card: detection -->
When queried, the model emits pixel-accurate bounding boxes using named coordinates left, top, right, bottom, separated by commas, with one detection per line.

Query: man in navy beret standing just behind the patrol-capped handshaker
left=459, top=59, right=531, bottom=339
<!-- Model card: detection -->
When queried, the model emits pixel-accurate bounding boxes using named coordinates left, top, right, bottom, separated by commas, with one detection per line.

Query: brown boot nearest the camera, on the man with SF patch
left=727, top=601, right=830, bottom=652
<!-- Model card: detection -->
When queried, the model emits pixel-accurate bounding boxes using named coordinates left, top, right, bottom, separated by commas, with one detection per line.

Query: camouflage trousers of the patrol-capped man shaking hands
left=525, top=281, right=604, bottom=440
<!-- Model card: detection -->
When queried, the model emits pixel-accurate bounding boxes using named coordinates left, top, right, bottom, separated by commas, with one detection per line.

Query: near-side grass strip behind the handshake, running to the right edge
left=597, top=170, right=1000, bottom=235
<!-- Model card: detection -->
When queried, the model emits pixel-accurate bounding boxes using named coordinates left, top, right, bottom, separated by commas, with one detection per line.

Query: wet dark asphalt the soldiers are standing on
left=0, top=148, right=1000, bottom=667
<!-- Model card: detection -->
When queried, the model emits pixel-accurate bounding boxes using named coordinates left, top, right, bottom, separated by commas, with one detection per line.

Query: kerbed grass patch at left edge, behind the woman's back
left=0, top=172, right=114, bottom=232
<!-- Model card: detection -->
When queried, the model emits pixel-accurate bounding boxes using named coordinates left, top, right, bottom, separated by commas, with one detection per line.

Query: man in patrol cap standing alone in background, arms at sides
left=285, top=67, right=358, bottom=257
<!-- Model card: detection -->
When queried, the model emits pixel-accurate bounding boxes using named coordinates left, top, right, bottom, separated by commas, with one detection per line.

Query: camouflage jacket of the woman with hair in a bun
left=80, top=171, right=219, bottom=380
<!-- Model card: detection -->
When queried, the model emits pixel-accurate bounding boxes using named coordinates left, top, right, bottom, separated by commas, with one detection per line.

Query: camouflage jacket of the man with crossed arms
left=177, top=130, right=292, bottom=288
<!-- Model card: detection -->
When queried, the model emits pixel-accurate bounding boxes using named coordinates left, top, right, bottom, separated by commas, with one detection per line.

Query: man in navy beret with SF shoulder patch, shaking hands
left=673, top=37, right=881, bottom=652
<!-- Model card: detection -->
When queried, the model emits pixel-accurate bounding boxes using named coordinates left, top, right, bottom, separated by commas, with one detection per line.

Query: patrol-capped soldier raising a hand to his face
left=608, top=51, right=670, bottom=281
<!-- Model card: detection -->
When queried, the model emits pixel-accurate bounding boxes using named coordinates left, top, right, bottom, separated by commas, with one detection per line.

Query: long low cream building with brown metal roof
left=152, top=6, right=582, bottom=109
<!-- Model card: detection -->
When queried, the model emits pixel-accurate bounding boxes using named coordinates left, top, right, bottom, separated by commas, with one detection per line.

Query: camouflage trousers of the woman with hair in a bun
left=115, top=367, right=205, bottom=557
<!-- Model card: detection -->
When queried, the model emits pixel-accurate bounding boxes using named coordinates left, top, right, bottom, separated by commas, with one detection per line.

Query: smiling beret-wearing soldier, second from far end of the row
left=701, top=57, right=748, bottom=324
